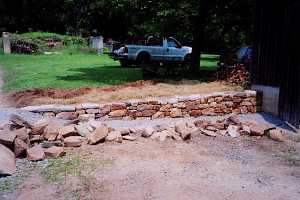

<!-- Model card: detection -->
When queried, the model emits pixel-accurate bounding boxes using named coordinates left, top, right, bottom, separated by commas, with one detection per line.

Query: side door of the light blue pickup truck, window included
left=164, top=38, right=182, bottom=61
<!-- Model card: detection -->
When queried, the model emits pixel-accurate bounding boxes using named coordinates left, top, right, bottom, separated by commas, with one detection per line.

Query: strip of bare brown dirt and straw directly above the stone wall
left=10, top=80, right=241, bottom=107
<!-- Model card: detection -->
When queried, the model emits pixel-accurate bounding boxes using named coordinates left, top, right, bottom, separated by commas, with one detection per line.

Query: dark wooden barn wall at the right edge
left=251, top=0, right=300, bottom=128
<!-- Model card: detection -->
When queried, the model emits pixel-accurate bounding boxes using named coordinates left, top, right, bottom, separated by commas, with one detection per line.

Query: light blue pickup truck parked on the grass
left=110, top=36, right=192, bottom=67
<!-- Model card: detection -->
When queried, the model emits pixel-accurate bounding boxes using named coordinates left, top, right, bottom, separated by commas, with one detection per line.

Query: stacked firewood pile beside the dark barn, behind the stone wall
left=216, top=64, right=250, bottom=85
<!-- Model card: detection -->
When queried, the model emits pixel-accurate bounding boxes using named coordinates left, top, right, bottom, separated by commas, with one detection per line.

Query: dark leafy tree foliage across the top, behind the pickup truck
left=0, top=0, right=255, bottom=52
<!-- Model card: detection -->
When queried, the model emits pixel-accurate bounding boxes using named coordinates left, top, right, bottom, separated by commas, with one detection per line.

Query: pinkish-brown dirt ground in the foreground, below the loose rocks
left=0, top=132, right=300, bottom=200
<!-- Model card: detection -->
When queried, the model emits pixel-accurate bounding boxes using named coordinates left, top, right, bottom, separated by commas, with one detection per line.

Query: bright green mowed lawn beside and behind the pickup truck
left=0, top=53, right=218, bottom=92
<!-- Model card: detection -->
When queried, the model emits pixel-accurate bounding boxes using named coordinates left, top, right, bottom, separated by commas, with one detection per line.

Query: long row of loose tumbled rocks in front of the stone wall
left=0, top=115, right=284, bottom=175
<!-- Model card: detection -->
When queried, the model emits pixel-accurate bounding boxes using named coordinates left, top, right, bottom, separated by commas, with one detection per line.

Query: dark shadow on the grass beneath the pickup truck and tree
left=57, top=66, right=217, bottom=85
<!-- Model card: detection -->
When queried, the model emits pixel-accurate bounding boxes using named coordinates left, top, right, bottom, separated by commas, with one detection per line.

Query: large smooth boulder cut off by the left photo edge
left=0, top=144, right=16, bottom=175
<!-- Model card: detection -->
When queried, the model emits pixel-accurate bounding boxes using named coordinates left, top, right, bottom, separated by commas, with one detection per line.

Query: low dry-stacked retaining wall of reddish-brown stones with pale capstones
left=22, top=90, right=261, bottom=120
